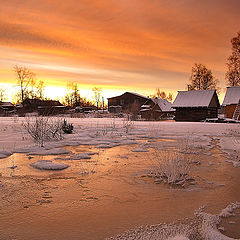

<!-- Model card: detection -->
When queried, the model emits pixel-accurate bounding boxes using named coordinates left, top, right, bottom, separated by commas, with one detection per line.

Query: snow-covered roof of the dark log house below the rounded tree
left=172, top=90, right=216, bottom=108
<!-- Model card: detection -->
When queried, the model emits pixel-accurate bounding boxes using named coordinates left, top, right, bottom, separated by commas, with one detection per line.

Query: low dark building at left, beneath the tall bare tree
left=18, top=98, right=66, bottom=115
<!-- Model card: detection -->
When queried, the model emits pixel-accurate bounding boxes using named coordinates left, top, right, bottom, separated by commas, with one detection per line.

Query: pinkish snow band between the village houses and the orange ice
left=0, top=117, right=240, bottom=158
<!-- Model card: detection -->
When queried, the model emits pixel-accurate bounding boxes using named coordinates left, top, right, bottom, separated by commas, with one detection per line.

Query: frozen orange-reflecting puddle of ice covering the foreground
left=0, top=141, right=240, bottom=240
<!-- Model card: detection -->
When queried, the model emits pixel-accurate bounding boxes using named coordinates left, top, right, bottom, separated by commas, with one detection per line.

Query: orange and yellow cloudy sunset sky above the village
left=0, top=0, right=240, bottom=100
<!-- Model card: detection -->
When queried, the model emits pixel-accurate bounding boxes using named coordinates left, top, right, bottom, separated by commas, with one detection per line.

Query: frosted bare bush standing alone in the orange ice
left=152, top=150, right=193, bottom=186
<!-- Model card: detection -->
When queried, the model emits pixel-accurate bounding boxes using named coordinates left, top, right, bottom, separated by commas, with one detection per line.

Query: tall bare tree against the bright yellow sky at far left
left=14, top=65, right=35, bottom=101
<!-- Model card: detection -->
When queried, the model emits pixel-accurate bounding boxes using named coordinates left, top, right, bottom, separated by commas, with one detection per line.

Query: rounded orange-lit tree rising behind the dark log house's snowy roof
left=188, top=63, right=218, bottom=90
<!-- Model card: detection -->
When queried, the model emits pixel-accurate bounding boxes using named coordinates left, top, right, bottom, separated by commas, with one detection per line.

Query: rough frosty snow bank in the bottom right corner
left=109, top=203, right=240, bottom=240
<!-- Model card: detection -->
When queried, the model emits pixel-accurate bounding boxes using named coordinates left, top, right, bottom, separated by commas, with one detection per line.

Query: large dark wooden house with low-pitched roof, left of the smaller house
left=108, top=92, right=148, bottom=114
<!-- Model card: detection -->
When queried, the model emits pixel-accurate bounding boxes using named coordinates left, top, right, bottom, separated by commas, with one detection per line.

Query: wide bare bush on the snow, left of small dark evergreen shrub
left=23, top=117, right=63, bottom=147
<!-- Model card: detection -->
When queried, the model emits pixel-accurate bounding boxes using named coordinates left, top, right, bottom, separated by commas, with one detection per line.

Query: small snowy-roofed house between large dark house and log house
left=140, top=98, right=175, bottom=120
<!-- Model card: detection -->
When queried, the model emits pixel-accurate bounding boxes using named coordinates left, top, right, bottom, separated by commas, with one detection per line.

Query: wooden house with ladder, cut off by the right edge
left=222, top=87, right=240, bottom=120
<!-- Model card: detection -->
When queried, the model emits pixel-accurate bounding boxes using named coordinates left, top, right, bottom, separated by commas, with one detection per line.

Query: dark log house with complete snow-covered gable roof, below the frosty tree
left=172, top=90, right=220, bottom=122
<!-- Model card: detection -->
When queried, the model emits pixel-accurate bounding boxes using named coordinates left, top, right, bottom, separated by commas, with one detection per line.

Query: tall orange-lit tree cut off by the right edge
left=226, top=32, right=240, bottom=87
